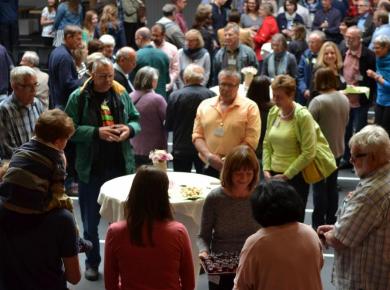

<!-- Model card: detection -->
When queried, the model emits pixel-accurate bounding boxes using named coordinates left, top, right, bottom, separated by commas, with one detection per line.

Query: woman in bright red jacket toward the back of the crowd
left=253, top=3, right=279, bottom=62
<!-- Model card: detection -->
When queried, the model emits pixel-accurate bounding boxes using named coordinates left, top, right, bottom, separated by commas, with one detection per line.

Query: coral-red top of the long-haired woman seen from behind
left=104, top=221, right=195, bottom=290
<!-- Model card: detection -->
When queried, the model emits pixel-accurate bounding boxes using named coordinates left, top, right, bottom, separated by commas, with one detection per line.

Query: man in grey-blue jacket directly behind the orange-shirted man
left=213, top=23, right=257, bottom=85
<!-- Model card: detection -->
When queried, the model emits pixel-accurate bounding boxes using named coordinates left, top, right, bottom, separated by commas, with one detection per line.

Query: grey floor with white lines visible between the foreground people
left=70, top=170, right=357, bottom=290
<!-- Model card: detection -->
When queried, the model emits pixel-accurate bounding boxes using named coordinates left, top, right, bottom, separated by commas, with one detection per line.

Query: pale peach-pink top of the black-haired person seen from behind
left=233, top=223, right=323, bottom=290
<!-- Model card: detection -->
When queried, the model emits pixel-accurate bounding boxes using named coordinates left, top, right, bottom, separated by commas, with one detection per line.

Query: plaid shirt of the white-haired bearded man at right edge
left=333, top=164, right=390, bottom=290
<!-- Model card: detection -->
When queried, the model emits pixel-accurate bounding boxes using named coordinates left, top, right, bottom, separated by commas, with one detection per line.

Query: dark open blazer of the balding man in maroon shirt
left=341, top=46, right=376, bottom=106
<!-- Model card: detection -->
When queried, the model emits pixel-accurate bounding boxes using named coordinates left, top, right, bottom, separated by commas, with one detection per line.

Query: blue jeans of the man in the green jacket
left=79, top=168, right=124, bottom=268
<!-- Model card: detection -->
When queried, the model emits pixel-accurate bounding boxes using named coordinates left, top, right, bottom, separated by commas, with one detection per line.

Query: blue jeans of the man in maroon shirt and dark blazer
left=343, top=106, right=368, bottom=162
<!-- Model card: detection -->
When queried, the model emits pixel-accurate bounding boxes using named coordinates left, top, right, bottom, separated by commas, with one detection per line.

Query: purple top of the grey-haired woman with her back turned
left=130, top=91, right=167, bottom=155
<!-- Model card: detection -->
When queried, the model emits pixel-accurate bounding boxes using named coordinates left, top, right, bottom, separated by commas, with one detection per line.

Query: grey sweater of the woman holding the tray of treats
left=198, top=187, right=260, bottom=253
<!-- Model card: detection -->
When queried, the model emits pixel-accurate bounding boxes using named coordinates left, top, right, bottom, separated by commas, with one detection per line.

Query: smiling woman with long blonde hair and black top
left=310, top=41, right=346, bottom=99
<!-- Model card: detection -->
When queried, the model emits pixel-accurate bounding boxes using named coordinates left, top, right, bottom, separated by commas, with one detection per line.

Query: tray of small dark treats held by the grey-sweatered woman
left=200, top=252, right=240, bottom=275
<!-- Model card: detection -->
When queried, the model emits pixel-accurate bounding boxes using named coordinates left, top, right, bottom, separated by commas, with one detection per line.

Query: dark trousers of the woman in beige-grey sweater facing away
left=312, top=158, right=341, bottom=229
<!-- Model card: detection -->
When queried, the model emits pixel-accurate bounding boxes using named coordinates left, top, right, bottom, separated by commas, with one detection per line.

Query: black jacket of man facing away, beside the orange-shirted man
left=165, top=85, right=215, bottom=155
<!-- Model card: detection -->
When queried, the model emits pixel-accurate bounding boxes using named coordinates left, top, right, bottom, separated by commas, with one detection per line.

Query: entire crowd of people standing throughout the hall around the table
left=0, top=0, right=390, bottom=290
